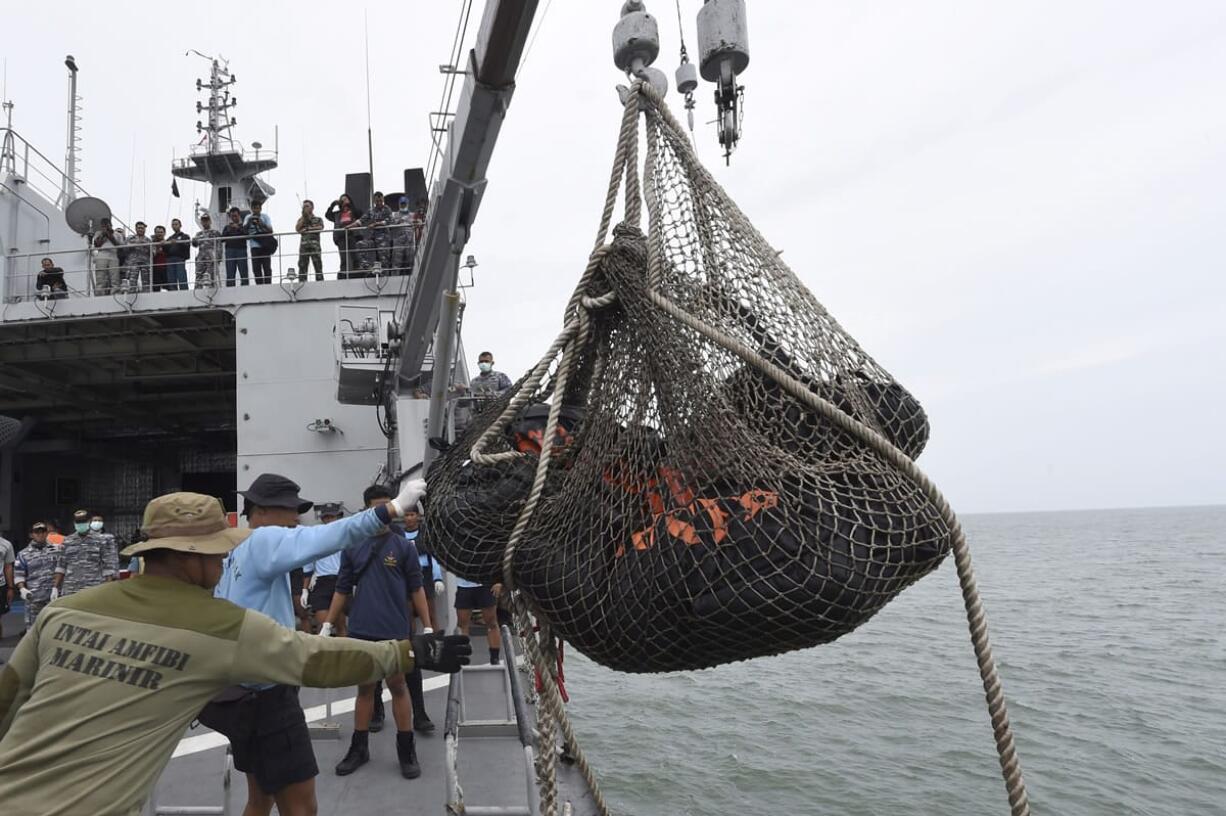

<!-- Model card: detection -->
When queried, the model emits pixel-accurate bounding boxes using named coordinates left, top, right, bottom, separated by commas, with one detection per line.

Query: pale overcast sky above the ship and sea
left=0, top=0, right=1226, bottom=509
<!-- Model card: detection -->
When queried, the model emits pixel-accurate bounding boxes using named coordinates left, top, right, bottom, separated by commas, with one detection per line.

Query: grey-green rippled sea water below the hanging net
left=566, top=507, right=1226, bottom=816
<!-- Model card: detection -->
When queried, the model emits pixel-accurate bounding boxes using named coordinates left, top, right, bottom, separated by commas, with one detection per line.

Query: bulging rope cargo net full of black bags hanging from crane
left=427, top=87, right=950, bottom=671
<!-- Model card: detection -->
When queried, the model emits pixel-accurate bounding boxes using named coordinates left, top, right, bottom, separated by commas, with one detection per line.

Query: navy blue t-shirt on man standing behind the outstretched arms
left=336, top=531, right=422, bottom=640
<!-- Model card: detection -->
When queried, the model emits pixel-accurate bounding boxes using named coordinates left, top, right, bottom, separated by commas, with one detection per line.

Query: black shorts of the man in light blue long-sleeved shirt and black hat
left=199, top=686, right=319, bottom=796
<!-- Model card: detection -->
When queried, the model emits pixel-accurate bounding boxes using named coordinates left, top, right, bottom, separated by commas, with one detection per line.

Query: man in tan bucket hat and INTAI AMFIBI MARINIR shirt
left=0, top=493, right=472, bottom=816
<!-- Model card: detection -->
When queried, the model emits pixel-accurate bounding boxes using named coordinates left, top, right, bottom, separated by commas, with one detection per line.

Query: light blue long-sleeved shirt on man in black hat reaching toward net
left=213, top=510, right=384, bottom=629
